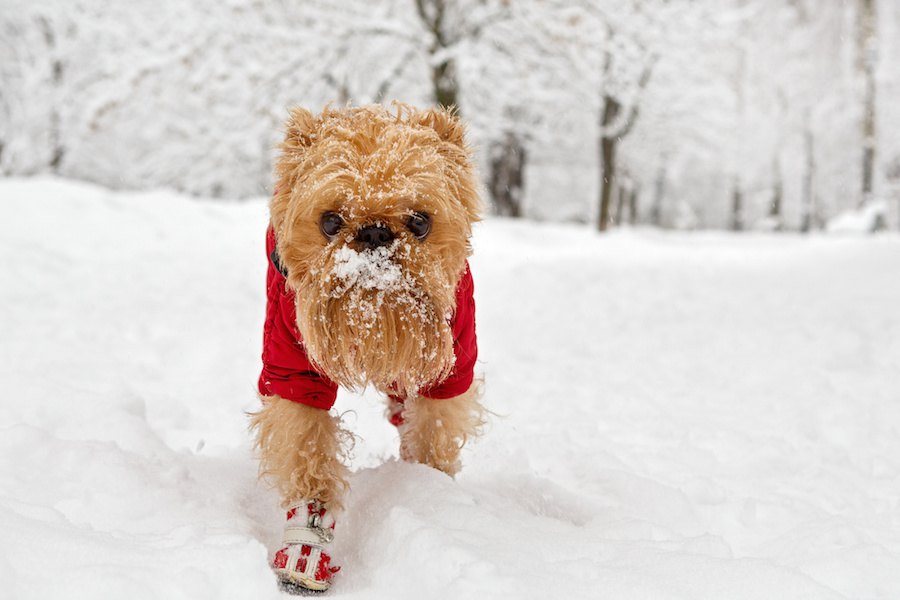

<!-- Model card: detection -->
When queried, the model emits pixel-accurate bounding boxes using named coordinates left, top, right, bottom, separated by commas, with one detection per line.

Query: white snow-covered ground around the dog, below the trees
left=0, top=179, right=900, bottom=600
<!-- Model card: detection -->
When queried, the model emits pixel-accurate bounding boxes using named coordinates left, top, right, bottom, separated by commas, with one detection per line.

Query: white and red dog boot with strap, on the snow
left=272, top=500, right=341, bottom=594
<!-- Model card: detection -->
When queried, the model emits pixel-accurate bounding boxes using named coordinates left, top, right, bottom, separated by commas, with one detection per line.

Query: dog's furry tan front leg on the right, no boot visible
left=400, top=381, right=485, bottom=475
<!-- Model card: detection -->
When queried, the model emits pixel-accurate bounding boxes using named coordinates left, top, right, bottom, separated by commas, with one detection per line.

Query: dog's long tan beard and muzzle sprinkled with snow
left=297, top=239, right=455, bottom=396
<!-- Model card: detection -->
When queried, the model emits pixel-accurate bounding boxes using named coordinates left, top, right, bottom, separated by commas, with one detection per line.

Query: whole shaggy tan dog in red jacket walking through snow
left=251, top=104, right=485, bottom=592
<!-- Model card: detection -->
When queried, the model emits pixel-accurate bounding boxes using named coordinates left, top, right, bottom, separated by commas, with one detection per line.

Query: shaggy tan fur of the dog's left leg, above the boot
left=250, top=396, right=352, bottom=510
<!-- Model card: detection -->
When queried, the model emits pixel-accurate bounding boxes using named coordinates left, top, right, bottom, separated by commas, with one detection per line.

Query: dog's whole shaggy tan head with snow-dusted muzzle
left=271, top=106, right=479, bottom=393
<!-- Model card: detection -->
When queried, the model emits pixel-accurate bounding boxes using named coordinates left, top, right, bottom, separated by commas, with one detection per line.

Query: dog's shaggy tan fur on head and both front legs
left=253, top=105, right=483, bottom=509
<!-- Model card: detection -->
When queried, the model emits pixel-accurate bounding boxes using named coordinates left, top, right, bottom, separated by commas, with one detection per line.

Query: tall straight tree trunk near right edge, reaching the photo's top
left=856, top=0, right=878, bottom=205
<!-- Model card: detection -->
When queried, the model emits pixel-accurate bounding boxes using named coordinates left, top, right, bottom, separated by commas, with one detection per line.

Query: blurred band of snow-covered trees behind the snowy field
left=0, top=0, right=900, bottom=231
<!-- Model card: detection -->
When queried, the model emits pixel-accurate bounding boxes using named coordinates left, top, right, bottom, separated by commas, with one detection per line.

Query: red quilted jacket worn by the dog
left=259, top=227, right=478, bottom=410
